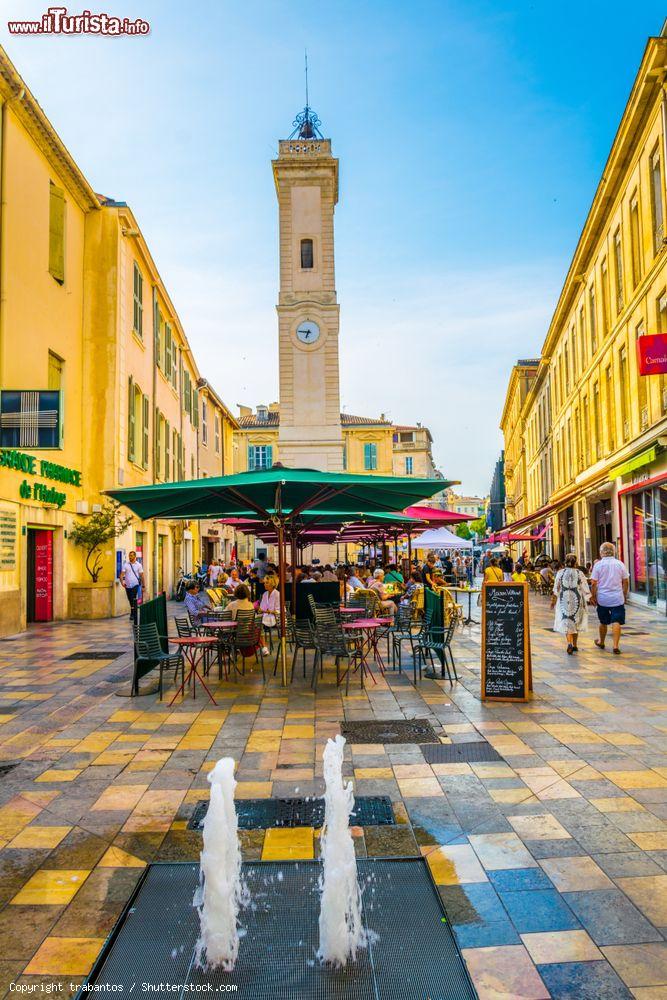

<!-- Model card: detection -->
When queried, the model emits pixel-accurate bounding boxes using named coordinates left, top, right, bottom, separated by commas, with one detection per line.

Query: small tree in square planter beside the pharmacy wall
left=69, top=500, right=132, bottom=618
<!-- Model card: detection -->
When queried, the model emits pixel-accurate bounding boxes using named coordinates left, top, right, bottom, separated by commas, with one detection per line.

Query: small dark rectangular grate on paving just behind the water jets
left=188, top=795, right=394, bottom=830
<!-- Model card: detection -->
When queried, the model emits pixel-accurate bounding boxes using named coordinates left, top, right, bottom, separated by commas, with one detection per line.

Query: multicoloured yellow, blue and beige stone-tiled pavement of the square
left=0, top=596, right=667, bottom=1000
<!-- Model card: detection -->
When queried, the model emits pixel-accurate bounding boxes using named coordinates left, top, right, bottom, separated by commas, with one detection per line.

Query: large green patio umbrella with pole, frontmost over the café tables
left=104, top=465, right=454, bottom=686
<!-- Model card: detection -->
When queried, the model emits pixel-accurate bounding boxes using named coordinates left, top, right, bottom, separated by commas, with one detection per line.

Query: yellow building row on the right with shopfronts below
left=503, top=31, right=667, bottom=604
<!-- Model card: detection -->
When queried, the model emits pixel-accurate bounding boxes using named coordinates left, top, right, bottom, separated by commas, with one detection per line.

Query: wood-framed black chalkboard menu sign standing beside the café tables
left=482, top=583, right=532, bottom=701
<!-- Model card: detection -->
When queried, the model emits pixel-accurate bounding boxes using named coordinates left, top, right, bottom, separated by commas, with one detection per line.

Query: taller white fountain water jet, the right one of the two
left=317, top=735, right=367, bottom=965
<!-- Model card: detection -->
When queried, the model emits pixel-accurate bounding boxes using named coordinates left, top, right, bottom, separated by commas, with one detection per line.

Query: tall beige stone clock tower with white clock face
left=273, top=105, right=343, bottom=472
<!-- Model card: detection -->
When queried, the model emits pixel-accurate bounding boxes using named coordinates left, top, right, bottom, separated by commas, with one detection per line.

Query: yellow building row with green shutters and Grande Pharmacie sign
left=0, top=49, right=237, bottom=634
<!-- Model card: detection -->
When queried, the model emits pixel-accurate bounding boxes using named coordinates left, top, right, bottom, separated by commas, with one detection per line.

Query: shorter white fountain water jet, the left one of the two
left=193, top=757, right=250, bottom=972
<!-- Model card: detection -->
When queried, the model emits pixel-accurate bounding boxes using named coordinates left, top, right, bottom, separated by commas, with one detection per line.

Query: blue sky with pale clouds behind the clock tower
left=0, top=0, right=665, bottom=492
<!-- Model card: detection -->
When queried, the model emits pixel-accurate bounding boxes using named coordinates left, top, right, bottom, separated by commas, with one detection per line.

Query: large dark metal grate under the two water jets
left=79, top=858, right=475, bottom=1000
